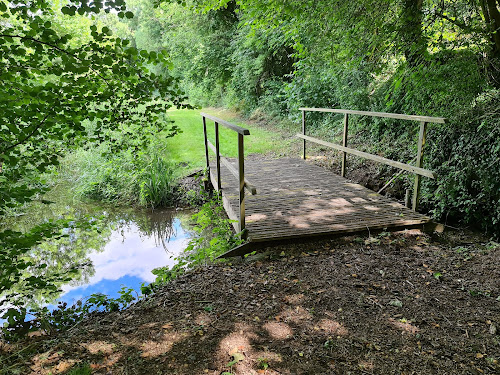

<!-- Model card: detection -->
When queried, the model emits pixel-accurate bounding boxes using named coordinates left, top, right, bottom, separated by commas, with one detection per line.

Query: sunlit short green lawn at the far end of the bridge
left=167, top=109, right=289, bottom=170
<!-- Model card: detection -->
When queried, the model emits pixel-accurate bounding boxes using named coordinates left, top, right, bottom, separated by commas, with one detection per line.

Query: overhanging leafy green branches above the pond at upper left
left=0, top=0, right=185, bottom=213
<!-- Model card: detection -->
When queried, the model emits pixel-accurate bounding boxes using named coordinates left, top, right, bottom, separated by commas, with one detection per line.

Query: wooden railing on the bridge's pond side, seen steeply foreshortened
left=200, top=112, right=257, bottom=232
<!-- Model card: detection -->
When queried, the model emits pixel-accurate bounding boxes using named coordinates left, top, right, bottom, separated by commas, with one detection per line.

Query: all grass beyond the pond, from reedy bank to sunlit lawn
left=60, top=110, right=286, bottom=208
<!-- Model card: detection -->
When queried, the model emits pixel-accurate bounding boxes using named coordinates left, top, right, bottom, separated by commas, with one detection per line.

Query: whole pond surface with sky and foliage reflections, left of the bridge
left=6, top=186, right=193, bottom=308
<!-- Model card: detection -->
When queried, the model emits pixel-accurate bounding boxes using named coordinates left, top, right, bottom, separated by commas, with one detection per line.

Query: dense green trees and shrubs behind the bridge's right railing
left=118, top=0, right=500, bottom=238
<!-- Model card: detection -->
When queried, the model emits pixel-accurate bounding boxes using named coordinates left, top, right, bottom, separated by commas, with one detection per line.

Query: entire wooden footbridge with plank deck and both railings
left=201, top=108, right=446, bottom=257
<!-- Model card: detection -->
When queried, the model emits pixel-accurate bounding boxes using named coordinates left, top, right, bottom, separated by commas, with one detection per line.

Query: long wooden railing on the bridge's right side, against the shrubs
left=297, top=108, right=448, bottom=211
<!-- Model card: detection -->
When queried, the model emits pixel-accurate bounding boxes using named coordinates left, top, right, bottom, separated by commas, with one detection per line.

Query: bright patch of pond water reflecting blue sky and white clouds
left=59, top=210, right=190, bottom=304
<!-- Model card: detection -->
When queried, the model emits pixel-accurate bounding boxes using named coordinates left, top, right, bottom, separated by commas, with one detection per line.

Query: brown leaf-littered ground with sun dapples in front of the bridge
left=1, top=231, right=500, bottom=375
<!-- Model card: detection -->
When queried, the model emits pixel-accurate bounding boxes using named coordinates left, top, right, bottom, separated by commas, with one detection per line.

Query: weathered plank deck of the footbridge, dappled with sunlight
left=210, top=159, right=430, bottom=242
